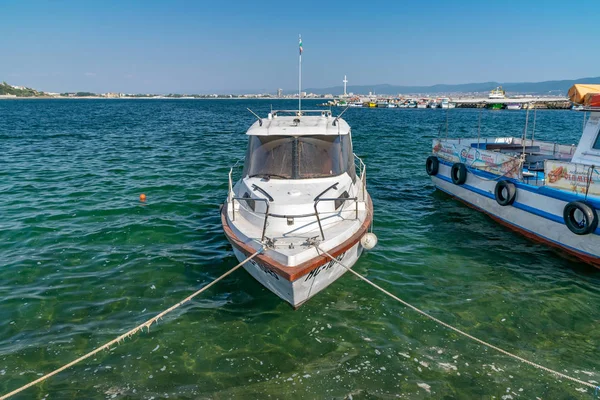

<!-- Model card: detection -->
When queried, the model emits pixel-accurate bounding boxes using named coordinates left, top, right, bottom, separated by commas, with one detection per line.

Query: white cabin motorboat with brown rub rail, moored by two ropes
left=221, top=110, right=376, bottom=307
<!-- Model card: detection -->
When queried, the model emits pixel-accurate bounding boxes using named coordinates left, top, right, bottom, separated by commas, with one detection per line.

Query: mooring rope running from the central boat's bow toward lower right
left=315, top=246, right=600, bottom=393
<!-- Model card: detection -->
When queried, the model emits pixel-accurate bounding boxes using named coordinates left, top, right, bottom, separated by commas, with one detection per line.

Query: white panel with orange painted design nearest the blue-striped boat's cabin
left=544, top=160, right=600, bottom=196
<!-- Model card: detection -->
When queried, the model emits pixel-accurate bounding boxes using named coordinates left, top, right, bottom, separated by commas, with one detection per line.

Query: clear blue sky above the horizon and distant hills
left=0, top=0, right=600, bottom=93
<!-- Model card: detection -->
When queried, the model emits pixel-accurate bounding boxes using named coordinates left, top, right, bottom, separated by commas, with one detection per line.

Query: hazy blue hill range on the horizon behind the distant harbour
left=305, top=77, right=600, bottom=95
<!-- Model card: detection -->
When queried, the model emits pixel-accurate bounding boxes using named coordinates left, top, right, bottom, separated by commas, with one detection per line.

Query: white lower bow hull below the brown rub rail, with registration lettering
left=233, top=242, right=363, bottom=307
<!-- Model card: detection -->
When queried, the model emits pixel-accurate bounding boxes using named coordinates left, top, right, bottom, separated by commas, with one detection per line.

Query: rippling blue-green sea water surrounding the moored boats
left=0, top=100, right=600, bottom=399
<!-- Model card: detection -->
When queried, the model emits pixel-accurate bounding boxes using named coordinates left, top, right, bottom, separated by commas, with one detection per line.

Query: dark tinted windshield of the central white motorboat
left=244, top=135, right=355, bottom=180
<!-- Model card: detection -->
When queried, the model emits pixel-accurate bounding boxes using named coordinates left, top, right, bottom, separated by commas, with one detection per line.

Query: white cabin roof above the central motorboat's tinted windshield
left=246, top=111, right=350, bottom=136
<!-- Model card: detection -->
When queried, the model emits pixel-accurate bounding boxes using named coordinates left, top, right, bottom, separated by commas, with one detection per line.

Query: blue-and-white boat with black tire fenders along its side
left=426, top=85, right=600, bottom=268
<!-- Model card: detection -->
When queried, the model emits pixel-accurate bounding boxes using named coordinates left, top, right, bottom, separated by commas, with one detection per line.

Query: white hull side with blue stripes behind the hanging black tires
left=431, top=162, right=600, bottom=264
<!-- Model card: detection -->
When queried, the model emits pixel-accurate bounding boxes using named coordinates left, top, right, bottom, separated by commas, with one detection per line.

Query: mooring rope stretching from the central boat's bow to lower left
left=0, top=248, right=263, bottom=400
